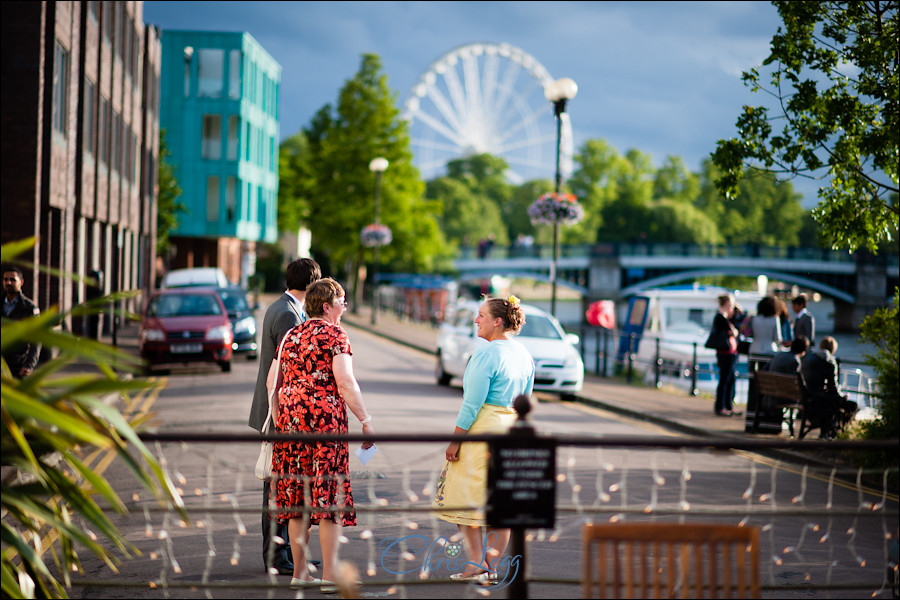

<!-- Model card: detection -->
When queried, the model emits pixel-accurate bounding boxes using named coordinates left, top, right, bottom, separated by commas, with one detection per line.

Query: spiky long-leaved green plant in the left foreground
left=0, top=238, right=188, bottom=598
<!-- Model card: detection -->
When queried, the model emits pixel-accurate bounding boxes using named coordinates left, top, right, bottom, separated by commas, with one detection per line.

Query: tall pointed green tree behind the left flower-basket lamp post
left=304, top=54, right=447, bottom=284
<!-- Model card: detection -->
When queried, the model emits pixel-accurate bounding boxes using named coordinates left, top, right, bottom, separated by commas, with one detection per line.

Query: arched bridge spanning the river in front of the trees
left=454, top=243, right=900, bottom=331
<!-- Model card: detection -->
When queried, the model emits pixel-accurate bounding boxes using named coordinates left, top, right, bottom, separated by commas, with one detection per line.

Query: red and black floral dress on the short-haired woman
left=272, top=319, right=356, bottom=526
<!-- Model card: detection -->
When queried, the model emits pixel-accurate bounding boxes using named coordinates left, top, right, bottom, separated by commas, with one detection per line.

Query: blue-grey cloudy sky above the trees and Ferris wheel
left=144, top=1, right=815, bottom=206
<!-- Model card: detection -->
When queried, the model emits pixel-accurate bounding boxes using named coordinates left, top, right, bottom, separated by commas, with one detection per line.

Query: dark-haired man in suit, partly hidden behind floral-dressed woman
left=249, top=258, right=322, bottom=575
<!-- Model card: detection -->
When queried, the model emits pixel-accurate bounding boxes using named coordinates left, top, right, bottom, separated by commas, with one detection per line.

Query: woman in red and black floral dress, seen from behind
left=270, top=278, right=374, bottom=589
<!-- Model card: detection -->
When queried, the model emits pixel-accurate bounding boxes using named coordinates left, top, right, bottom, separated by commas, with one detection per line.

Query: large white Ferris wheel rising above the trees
left=403, top=44, right=573, bottom=183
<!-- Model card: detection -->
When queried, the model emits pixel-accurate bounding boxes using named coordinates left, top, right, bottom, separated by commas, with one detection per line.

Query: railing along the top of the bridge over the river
left=457, top=242, right=864, bottom=264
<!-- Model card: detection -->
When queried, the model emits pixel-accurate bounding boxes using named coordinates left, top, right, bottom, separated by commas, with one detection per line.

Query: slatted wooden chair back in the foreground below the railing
left=582, top=523, right=759, bottom=598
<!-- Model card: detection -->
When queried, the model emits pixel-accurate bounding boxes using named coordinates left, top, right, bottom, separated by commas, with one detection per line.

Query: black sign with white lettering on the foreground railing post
left=485, top=395, right=556, bottom=598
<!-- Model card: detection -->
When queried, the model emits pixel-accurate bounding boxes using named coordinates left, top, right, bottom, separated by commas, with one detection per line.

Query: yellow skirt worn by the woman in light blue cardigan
left=431, top=404, right=517, bottom=527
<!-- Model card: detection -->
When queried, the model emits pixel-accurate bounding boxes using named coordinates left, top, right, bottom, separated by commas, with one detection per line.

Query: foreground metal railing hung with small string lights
left=58, top=420, right=898, bottom=598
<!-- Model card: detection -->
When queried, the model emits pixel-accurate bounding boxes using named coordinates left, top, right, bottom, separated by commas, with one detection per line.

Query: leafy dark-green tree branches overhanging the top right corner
left=712, top=1, right=900, bottom=251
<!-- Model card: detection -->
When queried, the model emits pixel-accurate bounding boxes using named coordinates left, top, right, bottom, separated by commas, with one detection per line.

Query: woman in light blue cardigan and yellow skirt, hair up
left=431, top=296, right=534, bottom=583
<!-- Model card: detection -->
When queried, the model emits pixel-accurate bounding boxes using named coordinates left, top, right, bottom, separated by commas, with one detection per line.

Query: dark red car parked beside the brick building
left=139, top=287, right=234, bottom=372
